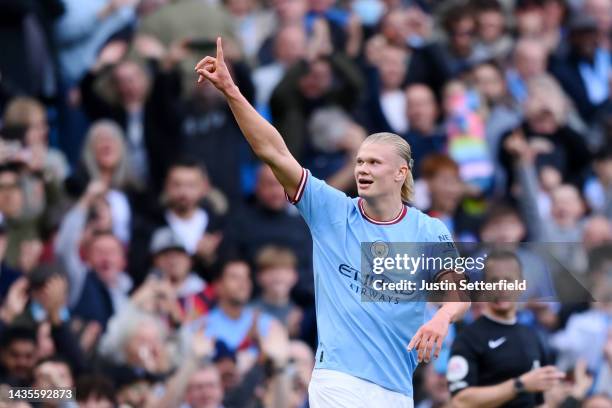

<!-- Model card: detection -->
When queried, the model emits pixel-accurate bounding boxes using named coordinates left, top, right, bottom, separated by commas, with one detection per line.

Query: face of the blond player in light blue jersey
left=355, top=141, right=408, bottom=198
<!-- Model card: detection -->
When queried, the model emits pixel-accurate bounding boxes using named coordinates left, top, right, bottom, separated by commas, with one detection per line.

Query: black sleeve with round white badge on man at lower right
left=446, top=335, right=478, bottom=395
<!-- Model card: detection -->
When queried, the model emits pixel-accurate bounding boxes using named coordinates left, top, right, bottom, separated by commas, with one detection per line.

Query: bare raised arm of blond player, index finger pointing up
left=195, top=37, right=302, bottom=197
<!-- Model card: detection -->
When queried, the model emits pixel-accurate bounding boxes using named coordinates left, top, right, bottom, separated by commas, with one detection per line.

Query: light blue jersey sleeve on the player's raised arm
left=287, top=169, right=351, bottom=231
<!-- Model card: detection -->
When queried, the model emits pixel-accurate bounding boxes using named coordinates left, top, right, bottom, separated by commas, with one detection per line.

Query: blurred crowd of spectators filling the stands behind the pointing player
left=0, top=0, right=612, bottom=408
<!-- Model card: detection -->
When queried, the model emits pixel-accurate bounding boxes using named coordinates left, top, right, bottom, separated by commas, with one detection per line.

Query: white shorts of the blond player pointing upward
left=308, top=368, right=414, bottom=408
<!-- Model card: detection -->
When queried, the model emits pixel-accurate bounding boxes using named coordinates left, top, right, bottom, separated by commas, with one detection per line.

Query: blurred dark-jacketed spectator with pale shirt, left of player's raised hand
left=80, top=47, right=184, bottom=192
